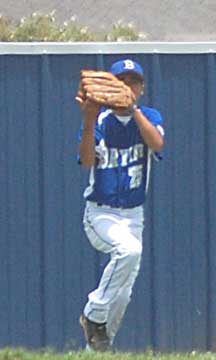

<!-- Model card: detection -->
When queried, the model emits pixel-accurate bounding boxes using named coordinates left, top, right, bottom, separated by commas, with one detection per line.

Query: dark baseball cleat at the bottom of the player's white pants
left=80, top=315, right=111, bottom=351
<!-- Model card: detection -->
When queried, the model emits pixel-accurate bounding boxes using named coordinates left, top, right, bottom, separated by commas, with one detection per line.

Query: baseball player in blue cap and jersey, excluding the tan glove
left=79, top=59, right=164, bottom=351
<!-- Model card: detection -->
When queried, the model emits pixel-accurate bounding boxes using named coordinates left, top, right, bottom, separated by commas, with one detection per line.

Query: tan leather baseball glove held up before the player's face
left=76, top=70, right=136, bottom=109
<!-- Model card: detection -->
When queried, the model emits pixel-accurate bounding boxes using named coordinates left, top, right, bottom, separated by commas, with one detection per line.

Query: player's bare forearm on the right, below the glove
left=133, top=109, right=164, bottom=151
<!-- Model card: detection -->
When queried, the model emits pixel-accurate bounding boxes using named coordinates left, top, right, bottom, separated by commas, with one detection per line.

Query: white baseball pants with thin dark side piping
left=83, top=202, right=144, bottom=343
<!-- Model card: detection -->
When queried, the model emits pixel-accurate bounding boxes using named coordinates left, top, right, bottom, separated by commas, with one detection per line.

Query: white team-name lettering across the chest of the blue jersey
left=96, top=140, right=144, bottom=169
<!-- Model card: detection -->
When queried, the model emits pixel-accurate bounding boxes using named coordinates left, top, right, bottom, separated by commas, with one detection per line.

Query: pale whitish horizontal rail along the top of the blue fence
left=0, top=42, right=216, bottom=55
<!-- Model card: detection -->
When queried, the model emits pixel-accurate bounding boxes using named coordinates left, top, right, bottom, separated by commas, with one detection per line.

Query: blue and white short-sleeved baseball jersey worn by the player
left=78, top=106, right=164, bottom=208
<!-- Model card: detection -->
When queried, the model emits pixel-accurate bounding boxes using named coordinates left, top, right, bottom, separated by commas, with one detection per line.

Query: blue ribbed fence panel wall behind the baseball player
left=0, top=45, right=216, bottom=351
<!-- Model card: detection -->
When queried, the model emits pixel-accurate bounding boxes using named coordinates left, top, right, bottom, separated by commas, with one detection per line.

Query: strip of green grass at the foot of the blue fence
left=0, top=349, right=216, bottom=360
